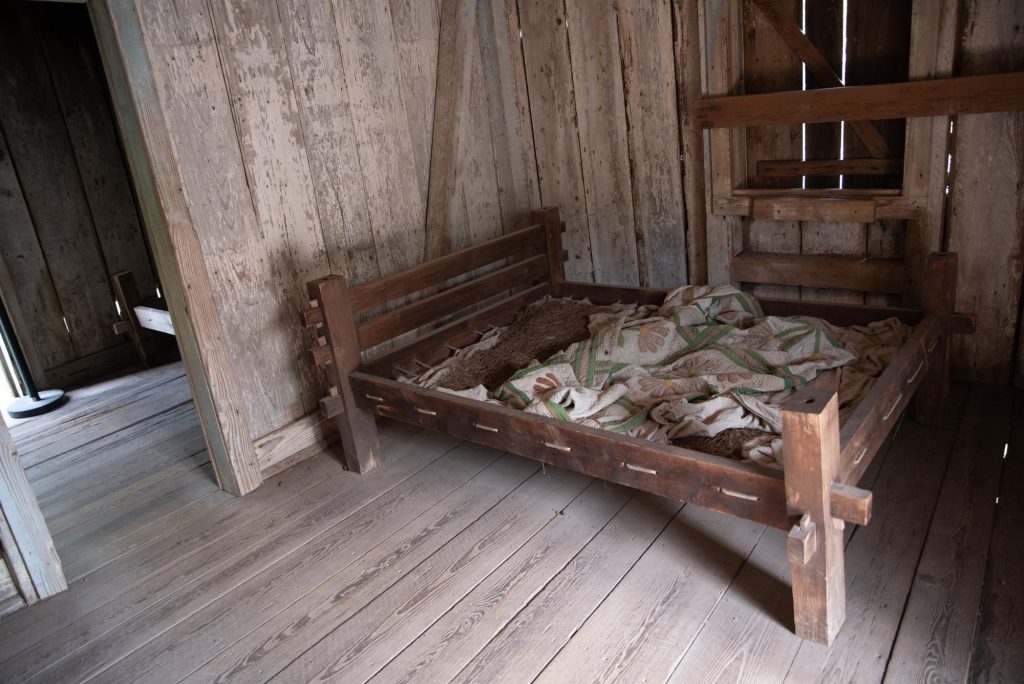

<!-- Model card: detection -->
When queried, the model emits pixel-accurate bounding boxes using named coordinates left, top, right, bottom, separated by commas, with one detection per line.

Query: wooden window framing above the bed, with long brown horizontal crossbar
left=681, top=0, right=1024, bottom=305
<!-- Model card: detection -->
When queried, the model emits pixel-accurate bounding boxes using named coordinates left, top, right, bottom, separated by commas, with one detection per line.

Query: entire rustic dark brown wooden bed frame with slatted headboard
left=304, top=208, right=974, bottom=643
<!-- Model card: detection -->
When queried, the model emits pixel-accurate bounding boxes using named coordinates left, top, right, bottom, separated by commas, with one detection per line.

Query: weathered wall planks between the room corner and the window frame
left=518, top=0, right=687, bottom=287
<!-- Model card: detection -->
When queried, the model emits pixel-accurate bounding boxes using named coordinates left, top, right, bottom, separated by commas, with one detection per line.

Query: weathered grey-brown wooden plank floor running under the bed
left=0, top=366, right=1024, bottom=682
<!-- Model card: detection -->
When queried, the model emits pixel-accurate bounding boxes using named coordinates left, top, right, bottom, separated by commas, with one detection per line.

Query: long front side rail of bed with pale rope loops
left=351, top=372, right=871, bottom=529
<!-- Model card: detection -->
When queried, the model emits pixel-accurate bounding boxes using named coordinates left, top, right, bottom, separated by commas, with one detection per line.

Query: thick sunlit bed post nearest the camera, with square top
left=782, top=389, right=846, bottom=644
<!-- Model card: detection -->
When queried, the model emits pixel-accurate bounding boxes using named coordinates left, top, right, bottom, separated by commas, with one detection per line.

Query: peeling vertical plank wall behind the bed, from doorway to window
left=90, top=0, right=1016, bottom=485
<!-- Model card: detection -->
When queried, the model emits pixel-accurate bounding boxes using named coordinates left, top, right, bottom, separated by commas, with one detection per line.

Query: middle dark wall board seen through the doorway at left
left=0, top=6, right=120, bottom=355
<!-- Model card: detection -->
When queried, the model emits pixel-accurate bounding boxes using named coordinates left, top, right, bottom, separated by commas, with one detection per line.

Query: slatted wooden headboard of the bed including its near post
left=302, top=207, right=566, bottom=472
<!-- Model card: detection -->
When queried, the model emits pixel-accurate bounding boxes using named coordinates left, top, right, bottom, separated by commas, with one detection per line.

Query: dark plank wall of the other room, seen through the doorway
left=0, top=3, right=156, bottom=386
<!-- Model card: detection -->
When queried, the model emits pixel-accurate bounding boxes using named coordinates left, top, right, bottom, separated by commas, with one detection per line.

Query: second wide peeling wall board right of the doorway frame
left=210, top=0, right=330, bottom=421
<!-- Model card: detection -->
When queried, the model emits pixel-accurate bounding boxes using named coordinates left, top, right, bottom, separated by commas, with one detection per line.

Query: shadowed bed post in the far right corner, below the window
left=913, top=252, right=956, bottom=425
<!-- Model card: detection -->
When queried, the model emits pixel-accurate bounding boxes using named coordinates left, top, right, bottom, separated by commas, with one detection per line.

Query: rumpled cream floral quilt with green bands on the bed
left=417, top=286, right=905, bottom=471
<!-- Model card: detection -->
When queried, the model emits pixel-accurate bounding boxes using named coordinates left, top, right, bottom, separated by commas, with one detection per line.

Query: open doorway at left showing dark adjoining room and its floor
left=0, top=2, right=223, bottom=613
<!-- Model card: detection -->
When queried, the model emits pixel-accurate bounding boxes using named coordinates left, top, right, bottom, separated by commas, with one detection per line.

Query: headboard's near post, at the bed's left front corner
left=305, top=275, right=381, bottom=473
